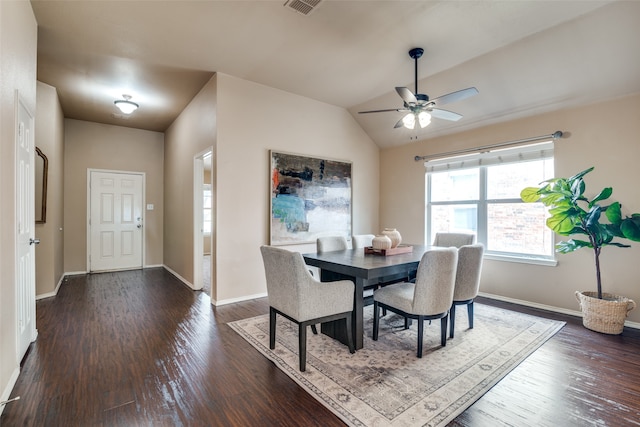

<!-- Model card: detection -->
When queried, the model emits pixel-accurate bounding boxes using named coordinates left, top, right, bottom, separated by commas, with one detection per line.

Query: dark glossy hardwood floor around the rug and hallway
left=0, top=268, right=640, bottom=427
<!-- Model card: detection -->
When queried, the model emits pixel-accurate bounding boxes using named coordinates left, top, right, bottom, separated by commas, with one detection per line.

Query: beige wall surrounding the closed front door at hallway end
left=64, top=119, right=165, bottom=273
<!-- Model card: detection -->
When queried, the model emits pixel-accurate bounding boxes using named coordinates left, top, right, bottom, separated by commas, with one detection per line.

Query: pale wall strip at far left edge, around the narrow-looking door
left=0, top=1, right=37, bottom=412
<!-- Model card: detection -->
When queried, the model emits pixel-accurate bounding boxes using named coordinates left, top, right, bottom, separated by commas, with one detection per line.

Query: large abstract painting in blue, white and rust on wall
left=269, top=150, right=353, bottom=246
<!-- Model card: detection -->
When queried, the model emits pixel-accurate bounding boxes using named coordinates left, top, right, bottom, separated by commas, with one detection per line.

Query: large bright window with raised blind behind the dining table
left=425, top=142, right=554, bottom=262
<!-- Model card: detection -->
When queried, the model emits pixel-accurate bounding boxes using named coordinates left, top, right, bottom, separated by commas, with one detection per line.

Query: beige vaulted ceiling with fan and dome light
left=31, top=0, right=640, bottom=147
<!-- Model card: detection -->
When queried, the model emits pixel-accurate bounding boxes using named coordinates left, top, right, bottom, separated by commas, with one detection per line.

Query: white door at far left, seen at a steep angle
left=16, top=100, right=36, bottom=360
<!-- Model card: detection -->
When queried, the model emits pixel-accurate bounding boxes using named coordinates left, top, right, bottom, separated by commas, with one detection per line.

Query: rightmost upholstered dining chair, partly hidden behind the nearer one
left=449, top=243, right=484, bottom=338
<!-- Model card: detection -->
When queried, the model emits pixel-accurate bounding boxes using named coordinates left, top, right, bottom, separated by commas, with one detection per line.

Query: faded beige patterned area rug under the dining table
left=229, top=303, right=564, bottom=427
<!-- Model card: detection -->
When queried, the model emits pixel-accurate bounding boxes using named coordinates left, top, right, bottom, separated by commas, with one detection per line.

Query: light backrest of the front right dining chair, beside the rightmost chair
left=412, top=248, right=458, bottom=315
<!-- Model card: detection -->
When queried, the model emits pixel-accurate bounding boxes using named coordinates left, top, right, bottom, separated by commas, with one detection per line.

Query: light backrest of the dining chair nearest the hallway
left=260, top=246, right=311, bottom=319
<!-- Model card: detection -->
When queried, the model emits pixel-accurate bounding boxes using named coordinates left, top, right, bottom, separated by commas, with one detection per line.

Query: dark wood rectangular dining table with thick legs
left=302, top=245, right=430, bottom=350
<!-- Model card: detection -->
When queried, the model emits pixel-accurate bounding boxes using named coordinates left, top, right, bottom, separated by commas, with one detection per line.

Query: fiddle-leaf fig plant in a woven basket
left=520, top=167, right=640, bottom=334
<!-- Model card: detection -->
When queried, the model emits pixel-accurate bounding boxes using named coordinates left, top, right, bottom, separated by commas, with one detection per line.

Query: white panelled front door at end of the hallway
left=89, top=171, right=143, bottom=271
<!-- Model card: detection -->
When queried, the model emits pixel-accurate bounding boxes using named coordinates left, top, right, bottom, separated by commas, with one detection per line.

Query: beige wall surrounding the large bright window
left=380, top=95, right=640, bottom=322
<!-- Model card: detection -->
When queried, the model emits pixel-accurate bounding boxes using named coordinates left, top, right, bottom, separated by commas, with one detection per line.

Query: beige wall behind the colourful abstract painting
left=214, top=74, right=380, bottom=302
